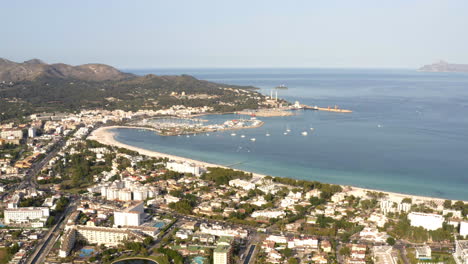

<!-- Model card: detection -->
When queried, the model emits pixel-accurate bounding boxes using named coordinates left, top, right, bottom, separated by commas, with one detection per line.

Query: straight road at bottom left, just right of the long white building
left=26, top=202, right=76, bottom=264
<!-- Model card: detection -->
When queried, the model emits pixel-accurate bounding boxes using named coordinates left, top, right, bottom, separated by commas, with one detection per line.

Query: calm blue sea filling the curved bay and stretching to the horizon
left=115, top=68, right=468, bottom=200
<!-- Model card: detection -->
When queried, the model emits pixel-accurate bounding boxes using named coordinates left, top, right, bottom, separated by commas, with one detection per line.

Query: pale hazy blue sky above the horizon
left=0, top=0, right=468, bottom=69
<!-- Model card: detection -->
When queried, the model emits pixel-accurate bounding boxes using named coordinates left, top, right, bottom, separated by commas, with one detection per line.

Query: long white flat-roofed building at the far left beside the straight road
left=3, top=207, right=49, bottom=225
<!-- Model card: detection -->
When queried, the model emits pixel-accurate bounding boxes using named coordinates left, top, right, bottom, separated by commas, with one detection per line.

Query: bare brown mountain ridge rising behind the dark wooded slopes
left=0, top=58, right=133, bottom=82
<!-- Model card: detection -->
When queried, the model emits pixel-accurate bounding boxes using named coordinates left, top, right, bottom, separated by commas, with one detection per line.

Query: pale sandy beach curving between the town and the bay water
left=87, top=126, right=468, bottom=205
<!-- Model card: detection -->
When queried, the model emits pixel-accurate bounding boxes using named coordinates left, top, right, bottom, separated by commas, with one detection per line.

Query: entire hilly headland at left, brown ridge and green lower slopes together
left=0, top=59, right=265, bottom=121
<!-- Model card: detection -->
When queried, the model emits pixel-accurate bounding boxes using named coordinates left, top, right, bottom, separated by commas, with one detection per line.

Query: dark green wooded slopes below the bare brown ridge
left=0, top=72, right=263, bottom=120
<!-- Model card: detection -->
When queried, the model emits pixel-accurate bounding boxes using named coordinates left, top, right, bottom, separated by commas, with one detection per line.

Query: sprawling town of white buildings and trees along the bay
left=0, top=107, right=468, bottom=264
